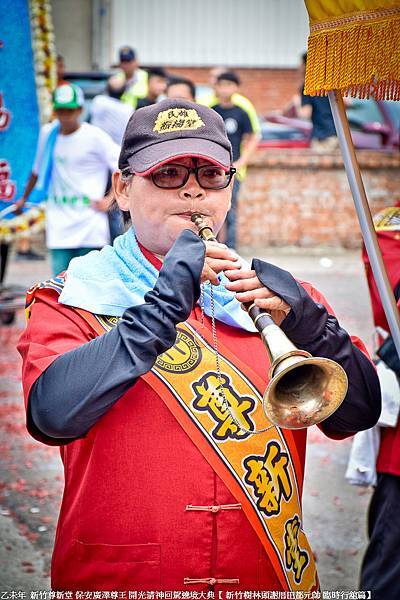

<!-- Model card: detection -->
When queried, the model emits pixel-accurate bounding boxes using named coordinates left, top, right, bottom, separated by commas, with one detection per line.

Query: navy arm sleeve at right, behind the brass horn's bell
left=252, top=259, right=381, bottom=436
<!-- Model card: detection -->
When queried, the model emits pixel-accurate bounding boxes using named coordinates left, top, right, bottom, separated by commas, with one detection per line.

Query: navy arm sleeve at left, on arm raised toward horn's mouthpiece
left=28, top=230, right=205, bottom=444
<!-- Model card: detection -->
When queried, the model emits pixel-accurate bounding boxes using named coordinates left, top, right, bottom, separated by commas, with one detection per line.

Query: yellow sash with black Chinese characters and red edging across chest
left=75, top=309, right=319, bottom=591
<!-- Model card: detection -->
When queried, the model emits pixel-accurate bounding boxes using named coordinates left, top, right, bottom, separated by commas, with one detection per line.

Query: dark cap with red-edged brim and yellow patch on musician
left=118, top=98, right=233, bottom=175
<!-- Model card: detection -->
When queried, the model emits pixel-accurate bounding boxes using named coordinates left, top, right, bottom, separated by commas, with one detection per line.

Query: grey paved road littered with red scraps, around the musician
left=0, top=248, right=372, bottom=592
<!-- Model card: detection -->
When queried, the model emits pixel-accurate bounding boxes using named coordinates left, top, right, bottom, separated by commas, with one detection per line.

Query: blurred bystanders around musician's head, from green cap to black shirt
left=16, top=46, right=260, bottom=266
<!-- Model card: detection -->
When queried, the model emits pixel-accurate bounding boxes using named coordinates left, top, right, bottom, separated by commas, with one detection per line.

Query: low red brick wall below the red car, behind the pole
left=238, top=149, right=400, bottom=248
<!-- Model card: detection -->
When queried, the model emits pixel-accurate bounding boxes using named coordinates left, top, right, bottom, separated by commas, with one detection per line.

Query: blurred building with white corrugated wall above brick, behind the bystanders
left=52, top=0, right=308, bottom=114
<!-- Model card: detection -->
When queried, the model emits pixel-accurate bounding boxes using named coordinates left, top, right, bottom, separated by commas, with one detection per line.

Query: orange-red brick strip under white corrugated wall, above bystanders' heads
left=166, top=67, right=300, bottom=115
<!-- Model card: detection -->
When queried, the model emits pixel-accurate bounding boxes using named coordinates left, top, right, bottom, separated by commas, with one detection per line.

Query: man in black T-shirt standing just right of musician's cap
left=212, top=71, right=258, bottom=248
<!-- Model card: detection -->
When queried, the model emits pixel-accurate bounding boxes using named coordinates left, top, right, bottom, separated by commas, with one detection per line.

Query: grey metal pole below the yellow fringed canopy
left=328, top=90, right=400, bottom=357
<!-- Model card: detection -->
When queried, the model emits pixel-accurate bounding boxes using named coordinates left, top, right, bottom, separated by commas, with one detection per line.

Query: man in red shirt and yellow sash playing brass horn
left=19, top=99, right=380, bottom=598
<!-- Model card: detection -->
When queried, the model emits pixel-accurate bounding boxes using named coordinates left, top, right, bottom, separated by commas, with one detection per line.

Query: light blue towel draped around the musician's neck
left=59, top=227, right=256, bottom=332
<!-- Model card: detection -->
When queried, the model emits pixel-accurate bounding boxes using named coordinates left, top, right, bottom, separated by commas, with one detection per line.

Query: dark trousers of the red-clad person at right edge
left=360, top=473, right=400, bottom=600
